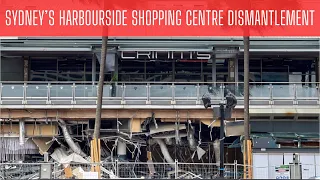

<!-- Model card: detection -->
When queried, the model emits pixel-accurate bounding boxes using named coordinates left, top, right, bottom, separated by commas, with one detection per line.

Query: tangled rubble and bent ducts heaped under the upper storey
left=0, top=118, right=235, bottom=179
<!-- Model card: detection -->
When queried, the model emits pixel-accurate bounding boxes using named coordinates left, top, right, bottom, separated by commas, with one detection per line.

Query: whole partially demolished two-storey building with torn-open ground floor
left=0, top=37, right=320, bottom=178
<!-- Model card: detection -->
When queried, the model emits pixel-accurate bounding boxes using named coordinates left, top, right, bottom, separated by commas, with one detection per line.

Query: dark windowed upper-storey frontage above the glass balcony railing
left=0, top=37, right=320, bottom=82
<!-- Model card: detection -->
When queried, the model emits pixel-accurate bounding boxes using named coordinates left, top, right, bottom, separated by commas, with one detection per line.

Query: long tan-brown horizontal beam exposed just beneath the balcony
left=1, top=106, right=243, bottom=120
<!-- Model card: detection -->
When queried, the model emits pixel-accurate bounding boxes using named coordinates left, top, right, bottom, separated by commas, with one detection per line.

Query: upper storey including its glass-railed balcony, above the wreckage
left=0, top=37, right=320, bottom=118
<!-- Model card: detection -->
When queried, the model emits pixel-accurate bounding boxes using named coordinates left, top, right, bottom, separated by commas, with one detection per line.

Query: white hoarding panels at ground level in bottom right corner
left=253, top=153, right=320, bottom=179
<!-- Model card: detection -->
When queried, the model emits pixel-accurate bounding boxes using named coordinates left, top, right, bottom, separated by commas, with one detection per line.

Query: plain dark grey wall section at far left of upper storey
left=0, top=57, right=23, bottom=81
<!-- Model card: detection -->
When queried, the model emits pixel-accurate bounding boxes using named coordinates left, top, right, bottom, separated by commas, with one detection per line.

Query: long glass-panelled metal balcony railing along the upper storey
left=0, top=82, right=320, bottom=105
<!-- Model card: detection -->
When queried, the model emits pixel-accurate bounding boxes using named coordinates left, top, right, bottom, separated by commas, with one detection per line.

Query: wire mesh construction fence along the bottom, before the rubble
left=0, top=161, right=320, bottom=180
